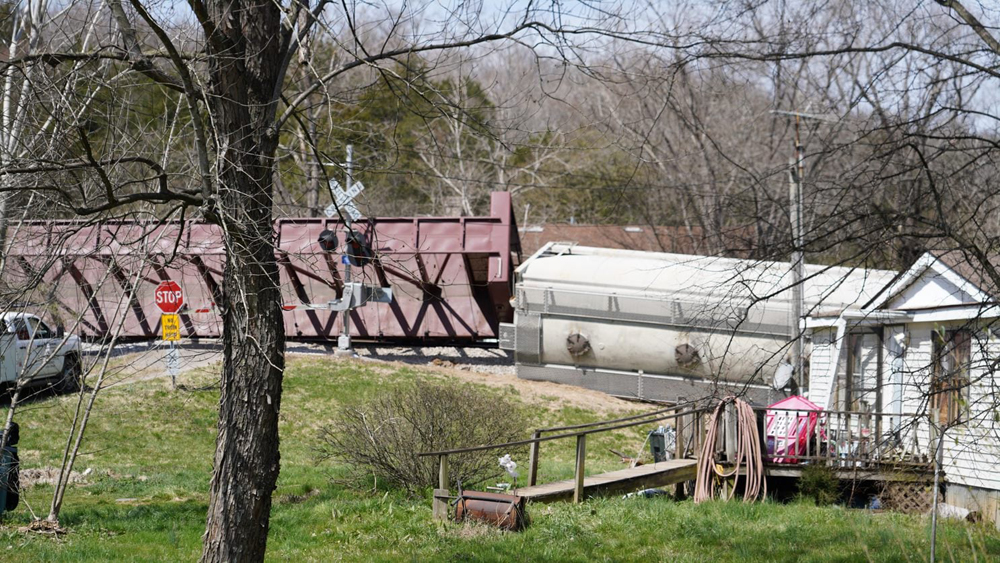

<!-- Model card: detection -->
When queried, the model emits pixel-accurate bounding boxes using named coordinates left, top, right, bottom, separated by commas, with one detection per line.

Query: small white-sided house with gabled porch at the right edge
left=806, top=251, right=1000, bottom=523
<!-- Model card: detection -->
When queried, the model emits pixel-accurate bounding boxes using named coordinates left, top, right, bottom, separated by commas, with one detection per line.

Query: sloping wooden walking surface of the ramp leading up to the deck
left=514, top=459, right=698, bottom=502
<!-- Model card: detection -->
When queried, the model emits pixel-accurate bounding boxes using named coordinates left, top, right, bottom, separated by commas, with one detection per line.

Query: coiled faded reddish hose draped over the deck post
left=694, top=397, right=767, bottom=503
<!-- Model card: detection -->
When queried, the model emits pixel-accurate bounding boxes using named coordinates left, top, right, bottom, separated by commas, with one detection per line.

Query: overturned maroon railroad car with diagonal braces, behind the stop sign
left=5, top=192, right=520, bottom=343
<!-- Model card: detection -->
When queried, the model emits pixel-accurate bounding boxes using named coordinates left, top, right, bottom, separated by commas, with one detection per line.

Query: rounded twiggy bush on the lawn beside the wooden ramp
left=318, top=380, right=528, bottom=492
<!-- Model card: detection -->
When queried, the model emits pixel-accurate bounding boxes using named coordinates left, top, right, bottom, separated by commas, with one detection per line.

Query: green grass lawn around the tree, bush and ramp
left=0, top=358, right=1000, bottom=561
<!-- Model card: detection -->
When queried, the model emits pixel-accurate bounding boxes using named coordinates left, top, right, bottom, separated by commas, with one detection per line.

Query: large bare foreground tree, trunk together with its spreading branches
left=2, top=0, right=656, bottom=561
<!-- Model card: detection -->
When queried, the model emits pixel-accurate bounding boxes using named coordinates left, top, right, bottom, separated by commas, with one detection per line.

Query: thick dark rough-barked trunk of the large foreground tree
left=202, top=0, right=285, bottom=561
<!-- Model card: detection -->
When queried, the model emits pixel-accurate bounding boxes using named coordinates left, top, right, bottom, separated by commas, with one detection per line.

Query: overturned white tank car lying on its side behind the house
left=501, top=243, right=896, bottom=402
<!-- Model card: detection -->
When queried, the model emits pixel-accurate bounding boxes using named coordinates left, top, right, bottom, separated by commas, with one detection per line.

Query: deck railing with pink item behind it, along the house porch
left=754, top=407, right=936, bottom=469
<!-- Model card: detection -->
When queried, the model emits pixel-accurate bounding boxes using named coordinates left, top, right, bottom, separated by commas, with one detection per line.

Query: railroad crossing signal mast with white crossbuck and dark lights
left=316, top=145, right=392, bottom=356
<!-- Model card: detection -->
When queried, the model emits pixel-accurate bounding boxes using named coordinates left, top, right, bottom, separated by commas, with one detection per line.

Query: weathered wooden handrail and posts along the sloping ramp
left=417, top=403, right=709, bottom=519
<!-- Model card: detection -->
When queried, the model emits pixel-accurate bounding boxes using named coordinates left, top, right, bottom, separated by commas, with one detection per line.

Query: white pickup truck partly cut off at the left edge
left=0, top=313, right=82, bottom=392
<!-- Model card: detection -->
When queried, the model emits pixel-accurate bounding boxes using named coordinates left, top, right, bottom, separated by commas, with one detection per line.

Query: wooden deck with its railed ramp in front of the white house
left=418, top=402, right=936, bottom=519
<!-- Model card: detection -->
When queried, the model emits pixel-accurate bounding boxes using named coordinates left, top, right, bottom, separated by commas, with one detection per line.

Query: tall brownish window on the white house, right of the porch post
left=931, top=329, right=972, bottom=425
